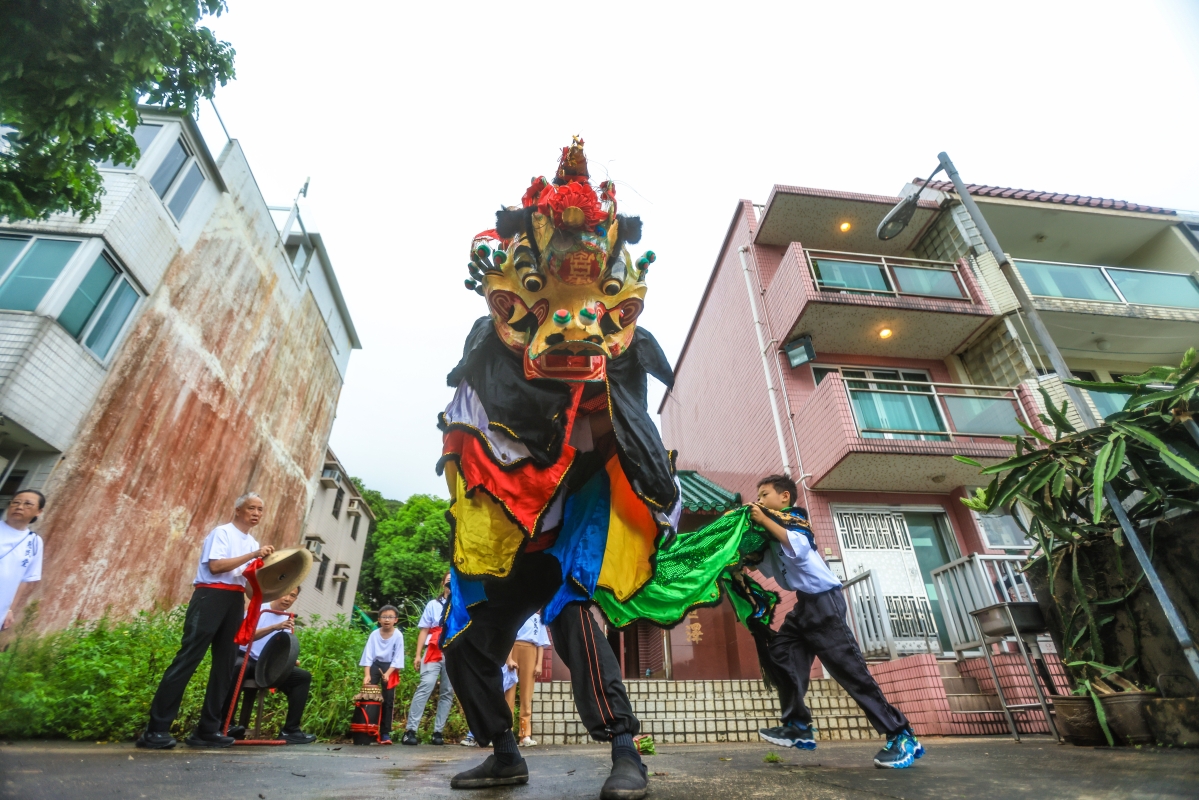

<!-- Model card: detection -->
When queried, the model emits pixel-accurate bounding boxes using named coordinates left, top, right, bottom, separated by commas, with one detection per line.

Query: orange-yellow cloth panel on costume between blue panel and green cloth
left=598, top=456, right=658, bottom=602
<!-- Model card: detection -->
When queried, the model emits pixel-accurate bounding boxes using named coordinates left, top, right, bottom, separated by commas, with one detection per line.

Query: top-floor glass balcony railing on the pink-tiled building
left=803, top=249, right=971, bottom=302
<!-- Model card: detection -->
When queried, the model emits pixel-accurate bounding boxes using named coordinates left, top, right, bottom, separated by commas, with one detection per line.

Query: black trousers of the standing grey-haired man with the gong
left=147, top=588, right=246, bottom=733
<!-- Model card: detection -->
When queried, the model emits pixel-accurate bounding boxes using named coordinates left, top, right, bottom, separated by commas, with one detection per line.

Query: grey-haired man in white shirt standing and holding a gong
left=137, top=492, right=275, bottom=750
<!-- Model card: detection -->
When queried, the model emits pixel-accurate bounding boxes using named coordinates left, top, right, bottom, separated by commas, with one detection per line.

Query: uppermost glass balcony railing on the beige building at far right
left=1016, top=260, right=1199, bottom=308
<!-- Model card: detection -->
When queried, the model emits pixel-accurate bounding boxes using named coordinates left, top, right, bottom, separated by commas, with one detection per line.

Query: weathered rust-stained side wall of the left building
left=28, top=144, right=342, bottom=628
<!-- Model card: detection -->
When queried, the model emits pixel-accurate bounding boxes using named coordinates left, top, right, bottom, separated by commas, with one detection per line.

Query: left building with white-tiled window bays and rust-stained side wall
left=0, top=107, right=361, bottom=627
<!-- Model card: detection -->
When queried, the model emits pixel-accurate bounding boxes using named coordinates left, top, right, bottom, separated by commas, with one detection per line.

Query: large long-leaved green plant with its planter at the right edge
left=954, top=349, right=1199, bottom=744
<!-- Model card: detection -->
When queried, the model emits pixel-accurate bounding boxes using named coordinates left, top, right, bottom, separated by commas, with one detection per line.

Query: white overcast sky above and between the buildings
left=201, top=0, right=1199, bottom=499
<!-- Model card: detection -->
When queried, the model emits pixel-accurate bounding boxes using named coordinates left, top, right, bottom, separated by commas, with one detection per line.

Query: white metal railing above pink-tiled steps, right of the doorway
left=932, top=553, right=1036, bottom=656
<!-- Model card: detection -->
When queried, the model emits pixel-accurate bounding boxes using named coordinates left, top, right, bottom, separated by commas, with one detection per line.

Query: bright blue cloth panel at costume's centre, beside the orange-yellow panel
left=542, top=469, right=611, bottom=625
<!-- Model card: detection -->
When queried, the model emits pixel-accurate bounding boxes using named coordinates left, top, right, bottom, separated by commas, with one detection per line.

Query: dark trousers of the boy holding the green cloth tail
left=770, top=589, right=909, bottom=735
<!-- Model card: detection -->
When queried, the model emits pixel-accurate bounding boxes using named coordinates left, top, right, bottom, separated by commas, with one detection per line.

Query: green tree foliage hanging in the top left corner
left=0, top=0, right=234, bottom=219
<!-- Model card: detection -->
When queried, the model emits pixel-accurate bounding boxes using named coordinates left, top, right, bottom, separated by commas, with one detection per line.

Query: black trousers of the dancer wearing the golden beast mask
left=445, top=552, right=640, bottom=746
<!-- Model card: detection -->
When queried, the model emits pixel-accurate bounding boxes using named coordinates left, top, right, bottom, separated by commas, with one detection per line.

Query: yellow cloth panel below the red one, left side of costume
left=445, top=462, right=524, bottom=578
